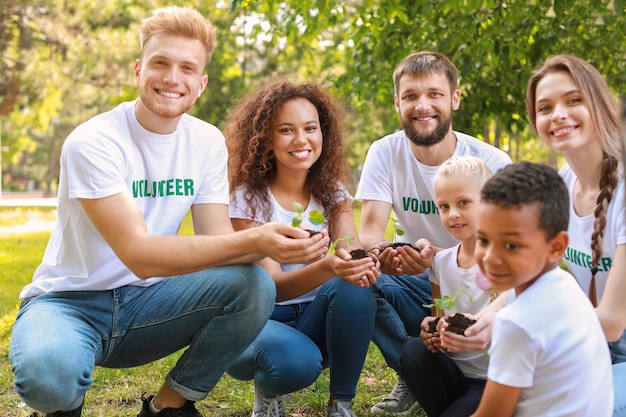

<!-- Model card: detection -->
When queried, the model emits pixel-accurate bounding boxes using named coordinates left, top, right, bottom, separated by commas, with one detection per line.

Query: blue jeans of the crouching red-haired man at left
left=9, top=265, right=276, bottom=413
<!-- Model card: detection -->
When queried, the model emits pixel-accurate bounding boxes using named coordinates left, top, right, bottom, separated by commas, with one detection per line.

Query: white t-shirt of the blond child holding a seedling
left=429, top=244, right=491, bottom=379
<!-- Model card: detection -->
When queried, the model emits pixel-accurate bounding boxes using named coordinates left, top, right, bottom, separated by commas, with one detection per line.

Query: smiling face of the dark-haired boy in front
left=474, top=202, right=567, bottom=294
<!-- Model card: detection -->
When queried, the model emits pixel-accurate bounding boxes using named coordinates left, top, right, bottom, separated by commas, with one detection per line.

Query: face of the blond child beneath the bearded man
left=435, top=175, right=480, bottom=241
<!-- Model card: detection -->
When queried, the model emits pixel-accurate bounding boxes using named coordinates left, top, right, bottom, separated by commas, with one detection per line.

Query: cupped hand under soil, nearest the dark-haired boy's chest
left=440, top=313, right=496, bottom=352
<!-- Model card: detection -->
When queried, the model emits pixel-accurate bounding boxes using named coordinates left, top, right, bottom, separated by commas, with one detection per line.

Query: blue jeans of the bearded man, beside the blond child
left=372, top=271, right=432, bottom=376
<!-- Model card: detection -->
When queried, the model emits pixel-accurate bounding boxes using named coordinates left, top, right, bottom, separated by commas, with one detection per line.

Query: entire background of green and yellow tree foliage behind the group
left=0, top=0, right=626, bottom=192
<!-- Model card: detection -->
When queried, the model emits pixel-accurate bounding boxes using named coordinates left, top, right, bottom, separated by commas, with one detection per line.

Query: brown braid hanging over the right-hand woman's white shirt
left=589, top=153, right=618, bottom=307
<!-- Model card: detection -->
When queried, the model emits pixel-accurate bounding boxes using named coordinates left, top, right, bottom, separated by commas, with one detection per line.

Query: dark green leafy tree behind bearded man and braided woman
left=233, top=0, right=626, bottom=166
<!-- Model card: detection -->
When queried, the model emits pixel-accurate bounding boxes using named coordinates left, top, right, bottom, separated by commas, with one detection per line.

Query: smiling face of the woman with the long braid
left=535, top=71, right=600, bottom=154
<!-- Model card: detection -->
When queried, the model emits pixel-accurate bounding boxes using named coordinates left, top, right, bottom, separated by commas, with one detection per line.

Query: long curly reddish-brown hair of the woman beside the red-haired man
left=224, top=79, right=348, bottom=227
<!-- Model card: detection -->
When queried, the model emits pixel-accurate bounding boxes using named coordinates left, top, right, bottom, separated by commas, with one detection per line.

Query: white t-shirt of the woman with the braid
left=559, top=165, right=626, bottom=302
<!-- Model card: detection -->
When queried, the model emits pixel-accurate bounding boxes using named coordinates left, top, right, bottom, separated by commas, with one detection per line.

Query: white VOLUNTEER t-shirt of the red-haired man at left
left=20, top=101, right=229, bottom=298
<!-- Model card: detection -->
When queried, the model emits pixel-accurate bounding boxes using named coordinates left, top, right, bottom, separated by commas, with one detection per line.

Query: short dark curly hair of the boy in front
left=480, top=161, right=569, bottom=240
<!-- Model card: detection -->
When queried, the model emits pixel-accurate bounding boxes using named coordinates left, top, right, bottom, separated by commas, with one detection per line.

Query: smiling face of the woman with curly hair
left=272, top=98, right=323, bottom=173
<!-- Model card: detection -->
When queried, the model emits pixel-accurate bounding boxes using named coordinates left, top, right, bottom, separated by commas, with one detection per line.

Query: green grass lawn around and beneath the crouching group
left=0, top=209, right=424, bottom=417
